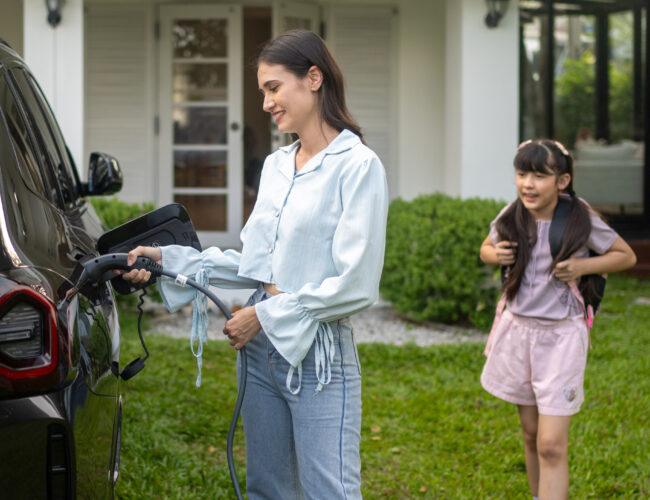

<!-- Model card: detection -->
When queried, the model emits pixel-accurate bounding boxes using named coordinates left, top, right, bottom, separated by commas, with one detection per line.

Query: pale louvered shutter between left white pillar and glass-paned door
left=84, top=3, right=156, bottom=203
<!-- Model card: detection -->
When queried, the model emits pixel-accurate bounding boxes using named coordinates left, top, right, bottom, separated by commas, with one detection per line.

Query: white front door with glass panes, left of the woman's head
left=158, top=5, right=243, bottom=248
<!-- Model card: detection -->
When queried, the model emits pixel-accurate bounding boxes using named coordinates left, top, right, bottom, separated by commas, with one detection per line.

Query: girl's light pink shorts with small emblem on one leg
left=481, top=310, right=589, bottom=416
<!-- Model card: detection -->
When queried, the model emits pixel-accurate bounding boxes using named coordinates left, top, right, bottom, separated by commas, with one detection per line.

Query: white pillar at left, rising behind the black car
left=23, top=0, right=86, bottom=176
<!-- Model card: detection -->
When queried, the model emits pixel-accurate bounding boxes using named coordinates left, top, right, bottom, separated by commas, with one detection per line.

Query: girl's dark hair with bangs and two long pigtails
left=496, top=139, right=591, bottom=300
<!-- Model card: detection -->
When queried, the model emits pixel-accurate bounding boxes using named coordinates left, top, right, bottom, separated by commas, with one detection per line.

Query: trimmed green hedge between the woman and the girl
left=380, top=194, right=504, bottom=330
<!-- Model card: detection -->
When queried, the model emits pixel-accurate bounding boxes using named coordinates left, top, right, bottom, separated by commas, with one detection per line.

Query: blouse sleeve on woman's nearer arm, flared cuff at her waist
left=255, top=157, right=388, bottom=367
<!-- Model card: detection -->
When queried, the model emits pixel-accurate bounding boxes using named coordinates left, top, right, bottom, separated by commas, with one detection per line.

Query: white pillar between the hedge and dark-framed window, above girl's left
left=445, top=0, right=519, bottom=200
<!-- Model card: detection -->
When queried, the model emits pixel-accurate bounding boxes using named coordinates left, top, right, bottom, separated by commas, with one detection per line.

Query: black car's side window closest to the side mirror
left=10, top=69, right=79, bottom=209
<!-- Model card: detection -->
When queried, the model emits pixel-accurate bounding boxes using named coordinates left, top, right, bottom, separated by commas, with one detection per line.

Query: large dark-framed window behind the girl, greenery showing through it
left=519, top=0, right=650, bottom=230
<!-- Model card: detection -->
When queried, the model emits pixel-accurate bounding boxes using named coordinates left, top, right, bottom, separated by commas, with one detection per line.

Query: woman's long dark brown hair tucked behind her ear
left=257, top=30, right=363, bottom=141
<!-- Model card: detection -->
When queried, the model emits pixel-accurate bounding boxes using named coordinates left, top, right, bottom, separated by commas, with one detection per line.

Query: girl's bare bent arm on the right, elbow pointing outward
left=554, top=236, right=636, bottom=281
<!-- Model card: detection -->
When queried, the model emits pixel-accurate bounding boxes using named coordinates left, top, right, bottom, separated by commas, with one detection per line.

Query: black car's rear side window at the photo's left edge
left=0, top=74, right=48, bottom=199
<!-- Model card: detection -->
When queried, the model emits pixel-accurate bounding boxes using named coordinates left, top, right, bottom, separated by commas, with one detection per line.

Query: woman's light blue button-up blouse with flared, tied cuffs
left=160, top=130, right=388, bottom=390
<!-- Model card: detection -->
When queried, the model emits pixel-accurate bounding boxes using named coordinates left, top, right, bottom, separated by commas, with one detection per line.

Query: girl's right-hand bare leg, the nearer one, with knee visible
left=537, top=415, right=571, bottom=500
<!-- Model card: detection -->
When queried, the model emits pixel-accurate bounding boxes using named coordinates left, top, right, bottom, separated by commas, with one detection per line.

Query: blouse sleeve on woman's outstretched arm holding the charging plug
left=158, top=245, right=259, bottom=312
